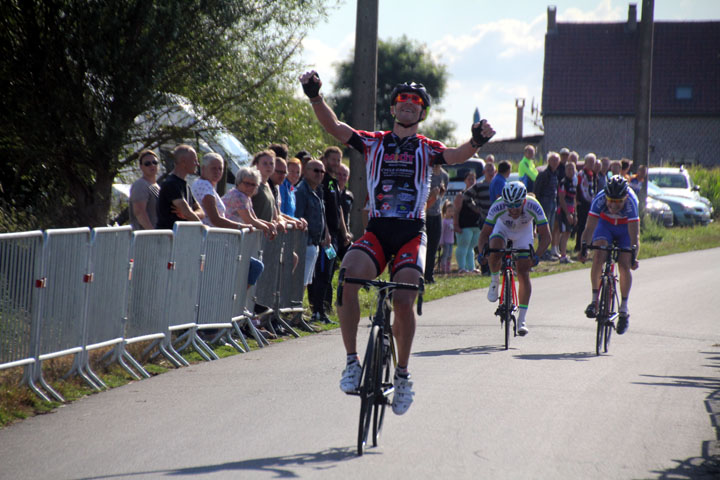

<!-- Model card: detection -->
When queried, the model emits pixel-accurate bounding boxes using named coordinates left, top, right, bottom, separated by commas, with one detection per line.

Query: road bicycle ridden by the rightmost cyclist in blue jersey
left=581, top=243, right=636, bottom=355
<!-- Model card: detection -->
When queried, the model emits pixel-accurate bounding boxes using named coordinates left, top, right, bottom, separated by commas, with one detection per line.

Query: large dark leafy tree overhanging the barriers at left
left=0, top=0, right=336, bottom=227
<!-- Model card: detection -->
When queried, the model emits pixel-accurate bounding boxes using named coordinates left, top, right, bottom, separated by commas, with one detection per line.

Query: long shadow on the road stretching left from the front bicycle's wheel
left=81, top=447, right=358, bottom=480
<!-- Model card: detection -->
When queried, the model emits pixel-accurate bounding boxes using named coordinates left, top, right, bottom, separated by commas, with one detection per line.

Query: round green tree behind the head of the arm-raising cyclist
left=331, top=36, right=455, bottom=142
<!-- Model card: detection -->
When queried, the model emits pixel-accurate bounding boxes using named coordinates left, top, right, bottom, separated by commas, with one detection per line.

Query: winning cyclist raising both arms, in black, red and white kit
left=300, top=70, right=495, bottom=415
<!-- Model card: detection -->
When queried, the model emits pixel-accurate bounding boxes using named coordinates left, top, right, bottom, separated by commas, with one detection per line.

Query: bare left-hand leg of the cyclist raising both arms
left=338, top=250, right=377, bottom=353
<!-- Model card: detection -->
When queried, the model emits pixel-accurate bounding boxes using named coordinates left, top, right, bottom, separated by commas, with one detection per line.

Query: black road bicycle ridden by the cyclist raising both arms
left=337, top=268, right=424, bottom=455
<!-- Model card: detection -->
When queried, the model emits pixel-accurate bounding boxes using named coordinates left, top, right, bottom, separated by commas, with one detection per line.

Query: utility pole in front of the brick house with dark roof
left=633, top=0, right=655, bottom=219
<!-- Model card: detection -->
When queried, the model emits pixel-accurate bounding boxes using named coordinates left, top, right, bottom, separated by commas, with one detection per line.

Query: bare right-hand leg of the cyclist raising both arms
left=392, top=267, right=422, bottom=367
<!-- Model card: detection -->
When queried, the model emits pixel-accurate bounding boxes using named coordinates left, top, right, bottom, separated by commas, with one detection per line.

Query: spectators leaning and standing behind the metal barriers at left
left=128, top=144, right=354, bottom=337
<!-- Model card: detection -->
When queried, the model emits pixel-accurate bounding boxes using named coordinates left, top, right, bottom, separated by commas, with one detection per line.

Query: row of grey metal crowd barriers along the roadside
left=0, top=222, right=307, bottom=401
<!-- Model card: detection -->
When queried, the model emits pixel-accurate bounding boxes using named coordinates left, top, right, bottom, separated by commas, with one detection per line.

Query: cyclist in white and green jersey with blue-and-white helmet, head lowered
left=478, top=181, right=552, bottom=336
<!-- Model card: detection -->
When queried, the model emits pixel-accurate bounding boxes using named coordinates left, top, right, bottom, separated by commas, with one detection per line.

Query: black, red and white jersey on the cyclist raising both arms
left=347, top=130, right=446, bottom=219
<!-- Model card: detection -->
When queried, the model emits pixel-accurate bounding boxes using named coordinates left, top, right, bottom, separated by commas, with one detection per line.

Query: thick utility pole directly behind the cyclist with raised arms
left=349, top=0, right=379, bottom=238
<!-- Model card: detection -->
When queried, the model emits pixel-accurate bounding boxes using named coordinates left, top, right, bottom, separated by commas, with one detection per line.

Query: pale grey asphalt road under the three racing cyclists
left=0, top=249, right=720, bottom=480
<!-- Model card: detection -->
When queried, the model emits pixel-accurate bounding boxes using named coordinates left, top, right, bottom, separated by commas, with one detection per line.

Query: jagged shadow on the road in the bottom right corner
left=634, top=351, right=720, bottom=480
